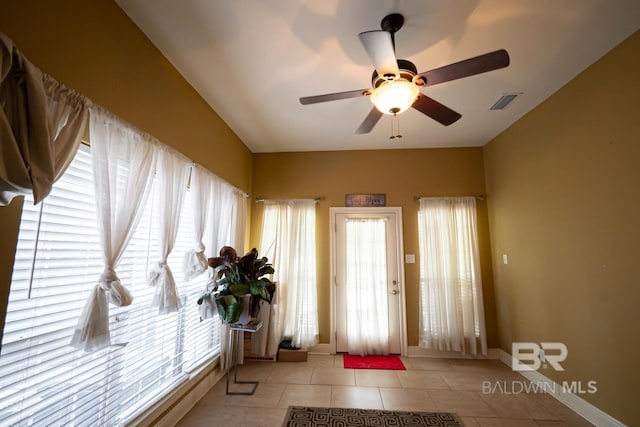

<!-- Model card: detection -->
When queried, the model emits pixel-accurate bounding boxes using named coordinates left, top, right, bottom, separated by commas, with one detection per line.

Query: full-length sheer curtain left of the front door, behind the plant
left=260, top=199, right=319, bottom=355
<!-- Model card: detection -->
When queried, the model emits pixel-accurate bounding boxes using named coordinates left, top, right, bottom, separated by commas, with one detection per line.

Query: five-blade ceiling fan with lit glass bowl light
left=300, top=13, right=509, bottom=134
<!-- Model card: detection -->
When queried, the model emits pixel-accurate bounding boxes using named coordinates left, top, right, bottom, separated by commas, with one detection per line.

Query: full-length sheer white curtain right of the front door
left=418, top=197, right=487, bottom=355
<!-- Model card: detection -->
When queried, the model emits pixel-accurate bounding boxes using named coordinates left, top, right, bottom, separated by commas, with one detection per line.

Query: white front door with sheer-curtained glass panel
left=332, top=208, right=404, bottom=354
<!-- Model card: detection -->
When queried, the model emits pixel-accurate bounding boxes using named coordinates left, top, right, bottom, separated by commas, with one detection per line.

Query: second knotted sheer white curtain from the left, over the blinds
left=149, top=148, right=191, bottom=314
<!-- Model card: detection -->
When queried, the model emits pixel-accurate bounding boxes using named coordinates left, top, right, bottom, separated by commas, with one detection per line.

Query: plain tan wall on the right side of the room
left=485, top=32, right=640, bottom=425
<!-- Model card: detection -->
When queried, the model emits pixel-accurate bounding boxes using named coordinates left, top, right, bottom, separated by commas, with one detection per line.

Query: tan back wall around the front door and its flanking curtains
left=251, top=148, right=497, bottom=346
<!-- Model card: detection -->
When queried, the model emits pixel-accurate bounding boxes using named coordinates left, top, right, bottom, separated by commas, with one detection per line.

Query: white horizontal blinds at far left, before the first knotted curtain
left=0, top=150, right=114, bottom=425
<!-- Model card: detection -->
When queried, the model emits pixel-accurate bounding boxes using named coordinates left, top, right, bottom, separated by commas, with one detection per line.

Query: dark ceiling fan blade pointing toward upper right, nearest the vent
left=419, top=49, right=509, bottom=86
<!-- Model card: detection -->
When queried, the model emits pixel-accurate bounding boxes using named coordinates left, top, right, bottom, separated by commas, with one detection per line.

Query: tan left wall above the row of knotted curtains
left=0, top=0, right=252, bottom=346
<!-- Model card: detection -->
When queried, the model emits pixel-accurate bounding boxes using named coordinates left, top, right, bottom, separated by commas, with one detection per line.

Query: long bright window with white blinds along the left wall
left=0, top=149, right=220, bottom=426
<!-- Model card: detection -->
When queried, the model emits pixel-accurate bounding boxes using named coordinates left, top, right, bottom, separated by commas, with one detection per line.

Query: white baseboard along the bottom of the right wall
left=496, top=349, right=625, bottom=427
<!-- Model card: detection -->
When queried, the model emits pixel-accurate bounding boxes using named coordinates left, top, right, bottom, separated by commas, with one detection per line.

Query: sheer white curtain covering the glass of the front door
left=345, top=218, right=389, bottom=356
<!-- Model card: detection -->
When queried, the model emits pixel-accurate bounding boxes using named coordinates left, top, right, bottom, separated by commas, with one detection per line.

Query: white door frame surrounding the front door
left=329, top=206, right=408, bottom=356
